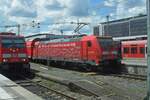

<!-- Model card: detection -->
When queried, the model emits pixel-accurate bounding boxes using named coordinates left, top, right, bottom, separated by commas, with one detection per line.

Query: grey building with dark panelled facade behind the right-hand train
left=93, top=15, right=147, bottom=37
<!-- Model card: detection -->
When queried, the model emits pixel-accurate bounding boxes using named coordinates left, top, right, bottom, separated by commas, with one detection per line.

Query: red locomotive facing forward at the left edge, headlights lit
left=0, top=32, right=30, bottom=71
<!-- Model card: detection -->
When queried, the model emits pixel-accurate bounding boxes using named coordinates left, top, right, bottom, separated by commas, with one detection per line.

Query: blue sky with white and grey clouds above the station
left=0, top=0, right=146, bottom=35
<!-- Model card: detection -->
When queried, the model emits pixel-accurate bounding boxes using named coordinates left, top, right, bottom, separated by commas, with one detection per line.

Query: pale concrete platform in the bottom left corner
left=0, top=74, right=42, bottom=100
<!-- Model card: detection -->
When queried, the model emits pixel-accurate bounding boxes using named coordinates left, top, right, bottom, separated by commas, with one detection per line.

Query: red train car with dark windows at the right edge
left=121, top=40, right=147, bottom=59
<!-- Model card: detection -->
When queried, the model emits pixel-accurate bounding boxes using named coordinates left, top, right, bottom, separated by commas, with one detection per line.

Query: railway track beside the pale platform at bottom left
left=15, top=75, right=77, bottom=100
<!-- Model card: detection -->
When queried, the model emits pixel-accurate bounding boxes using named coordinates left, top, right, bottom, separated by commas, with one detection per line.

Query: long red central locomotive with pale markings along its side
left=26, top=35, right=120, bottom=70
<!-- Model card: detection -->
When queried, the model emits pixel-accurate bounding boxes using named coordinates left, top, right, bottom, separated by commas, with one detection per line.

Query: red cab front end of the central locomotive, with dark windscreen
left=81, top=36, right=120, bottom=65
